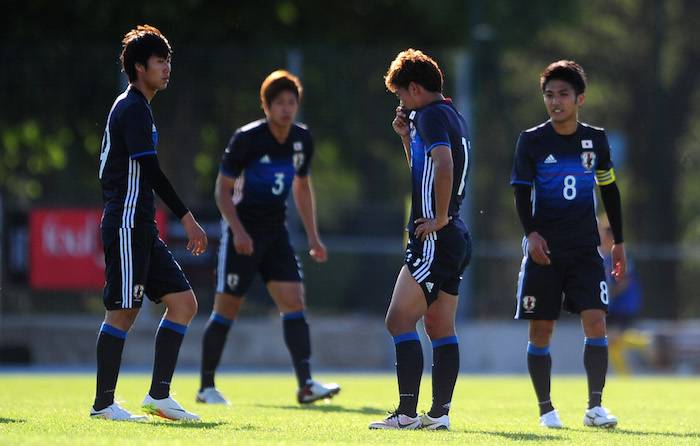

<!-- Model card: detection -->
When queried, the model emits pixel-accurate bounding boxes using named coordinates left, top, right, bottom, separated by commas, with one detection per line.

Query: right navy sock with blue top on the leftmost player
left=148, top=319, right=187, bottom=400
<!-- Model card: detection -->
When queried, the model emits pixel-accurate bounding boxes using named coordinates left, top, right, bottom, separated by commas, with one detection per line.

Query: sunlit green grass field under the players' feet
left=0, top=373, right=700, bottom=446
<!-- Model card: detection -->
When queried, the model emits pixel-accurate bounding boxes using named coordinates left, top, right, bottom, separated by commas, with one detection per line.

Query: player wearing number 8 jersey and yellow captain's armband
left=510, top=60, right=626, bottom=428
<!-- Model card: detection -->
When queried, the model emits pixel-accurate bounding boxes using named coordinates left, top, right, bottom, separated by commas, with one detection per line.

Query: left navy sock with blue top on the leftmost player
left=94, top=323, right=126, bottom=410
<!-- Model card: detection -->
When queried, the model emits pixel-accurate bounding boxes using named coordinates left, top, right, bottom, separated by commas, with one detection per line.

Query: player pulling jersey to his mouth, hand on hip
left=369, top=49, right=472, bottom=430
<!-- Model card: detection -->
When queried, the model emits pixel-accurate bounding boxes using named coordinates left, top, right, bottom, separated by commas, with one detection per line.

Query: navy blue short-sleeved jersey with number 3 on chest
left=219, top=118, right=314, bottom=233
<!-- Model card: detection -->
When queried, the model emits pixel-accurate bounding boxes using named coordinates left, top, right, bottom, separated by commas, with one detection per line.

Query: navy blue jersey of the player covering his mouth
left=406, top=99, right=471, bottom=240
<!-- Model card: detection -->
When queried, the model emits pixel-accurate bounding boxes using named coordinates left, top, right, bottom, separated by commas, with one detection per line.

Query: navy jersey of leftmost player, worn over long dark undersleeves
left=99, top=86, right=158, bottom=228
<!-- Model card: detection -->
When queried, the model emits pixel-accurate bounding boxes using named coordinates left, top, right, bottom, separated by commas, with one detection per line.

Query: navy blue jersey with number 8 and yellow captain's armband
left=510, top=121, right=615, bottom=251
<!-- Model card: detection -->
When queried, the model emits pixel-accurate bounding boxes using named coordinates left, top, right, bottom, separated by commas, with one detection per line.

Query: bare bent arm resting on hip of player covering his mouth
left=414, top=146, right=453, bottom=240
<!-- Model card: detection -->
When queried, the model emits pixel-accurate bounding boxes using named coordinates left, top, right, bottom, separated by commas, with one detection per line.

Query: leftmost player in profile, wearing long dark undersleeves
left=90, top=25, right=207, bottom=421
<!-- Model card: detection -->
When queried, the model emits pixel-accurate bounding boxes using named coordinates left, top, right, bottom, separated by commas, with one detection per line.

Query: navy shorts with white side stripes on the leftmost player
left=102, top=226, right=192, bottom=310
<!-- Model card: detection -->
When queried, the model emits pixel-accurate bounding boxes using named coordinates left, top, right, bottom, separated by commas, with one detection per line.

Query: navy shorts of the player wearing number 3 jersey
left=216, top=222, right=302, bottom=297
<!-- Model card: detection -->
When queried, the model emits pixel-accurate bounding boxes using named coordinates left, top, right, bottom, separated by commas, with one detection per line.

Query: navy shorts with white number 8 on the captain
left=515, top=242, right=610, bottom=320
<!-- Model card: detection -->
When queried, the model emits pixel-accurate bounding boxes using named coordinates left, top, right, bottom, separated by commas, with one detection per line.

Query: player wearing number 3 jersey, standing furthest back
left=197, top=70, right=340, bottom=404
